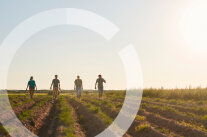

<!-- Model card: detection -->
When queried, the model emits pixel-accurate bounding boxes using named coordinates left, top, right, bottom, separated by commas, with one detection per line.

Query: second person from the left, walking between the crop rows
left=50, top=75, right=60, bottom=102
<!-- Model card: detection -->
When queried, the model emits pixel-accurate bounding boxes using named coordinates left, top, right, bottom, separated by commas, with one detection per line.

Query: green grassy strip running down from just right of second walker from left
left=57, top=96, right=75, bottom=137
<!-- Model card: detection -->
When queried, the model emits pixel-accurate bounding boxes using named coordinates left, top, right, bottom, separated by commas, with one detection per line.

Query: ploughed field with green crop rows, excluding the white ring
left=0, top=89, right=207, bottom=137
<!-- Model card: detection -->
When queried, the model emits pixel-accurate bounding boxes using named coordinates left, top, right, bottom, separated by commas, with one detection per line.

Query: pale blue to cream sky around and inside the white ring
left=0, top=0, right=207, bottom=89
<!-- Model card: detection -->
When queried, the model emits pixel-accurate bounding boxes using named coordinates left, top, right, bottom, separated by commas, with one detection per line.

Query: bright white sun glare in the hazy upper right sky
left=182, top=0, right=207, bottom=53
